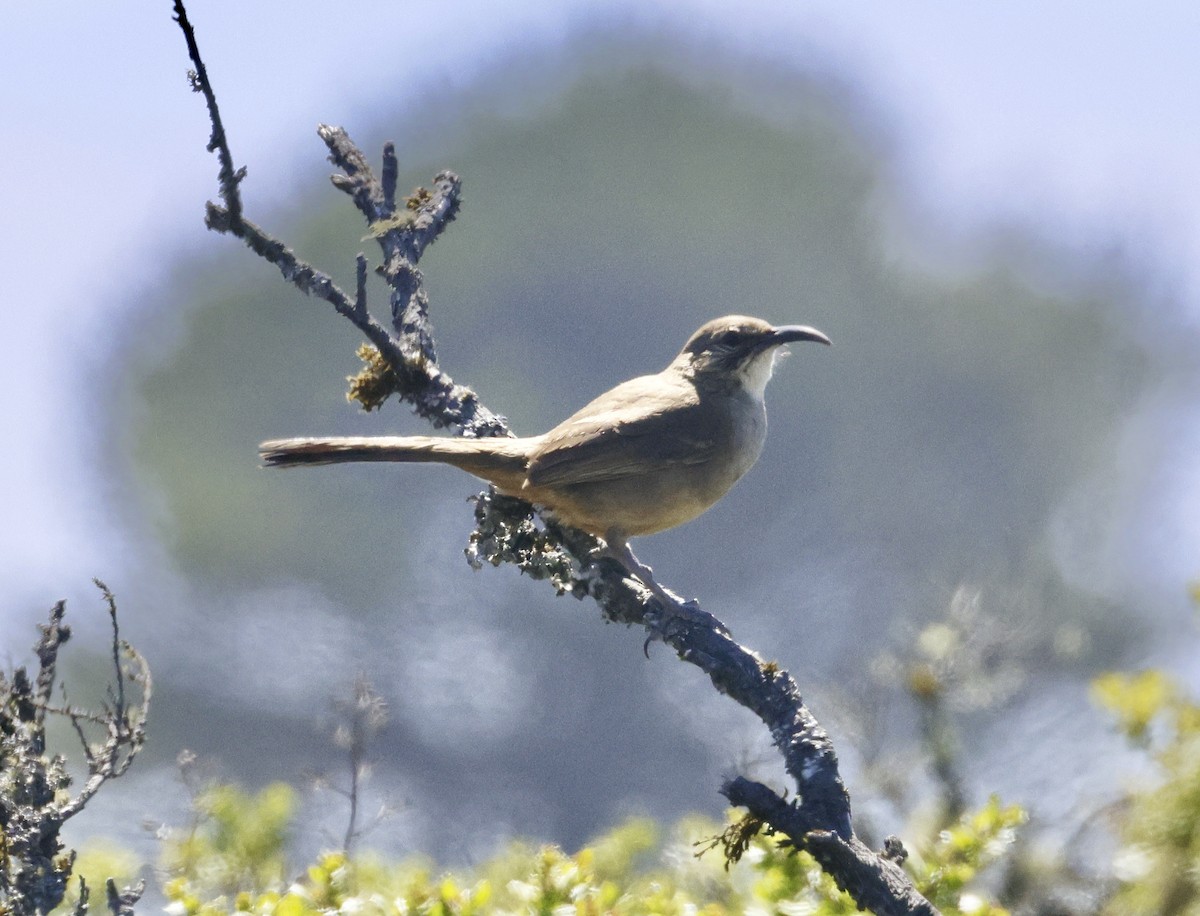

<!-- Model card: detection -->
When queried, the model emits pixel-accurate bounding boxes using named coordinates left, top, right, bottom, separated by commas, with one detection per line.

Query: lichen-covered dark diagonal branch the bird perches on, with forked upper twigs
left=176, top=2, right=936, bottom=915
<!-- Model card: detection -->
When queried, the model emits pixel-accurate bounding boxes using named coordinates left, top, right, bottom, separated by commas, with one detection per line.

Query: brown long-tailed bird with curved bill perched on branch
left=259, top=315, right=829, bottom=611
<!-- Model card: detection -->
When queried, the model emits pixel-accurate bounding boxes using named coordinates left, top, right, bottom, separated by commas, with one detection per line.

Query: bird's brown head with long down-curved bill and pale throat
left=673, top=315, right=829, bottom=397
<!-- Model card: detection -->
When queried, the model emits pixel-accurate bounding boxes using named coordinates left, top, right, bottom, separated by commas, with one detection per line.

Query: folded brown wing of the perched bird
left=527, top=376, right=716, bottom=486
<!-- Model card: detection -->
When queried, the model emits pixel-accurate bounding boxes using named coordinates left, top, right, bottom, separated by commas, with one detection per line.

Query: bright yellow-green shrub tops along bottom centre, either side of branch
left=142, top=784, right=1024, bottom=916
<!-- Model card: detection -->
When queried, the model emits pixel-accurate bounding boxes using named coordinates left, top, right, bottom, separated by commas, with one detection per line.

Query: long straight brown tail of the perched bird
left=258, top=436, right=530, bottom=491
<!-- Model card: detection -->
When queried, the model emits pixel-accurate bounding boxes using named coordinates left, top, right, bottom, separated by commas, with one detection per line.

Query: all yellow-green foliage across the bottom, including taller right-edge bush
left=39, top=648, right=1200, bottom=916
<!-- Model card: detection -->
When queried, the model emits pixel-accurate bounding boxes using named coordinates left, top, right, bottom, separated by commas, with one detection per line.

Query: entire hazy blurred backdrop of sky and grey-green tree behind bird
left=0, top=1, right=1200, bottom=873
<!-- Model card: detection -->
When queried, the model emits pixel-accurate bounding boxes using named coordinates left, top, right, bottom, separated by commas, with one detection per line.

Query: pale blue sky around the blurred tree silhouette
left=0, top=0, right=1200, bottom=624
